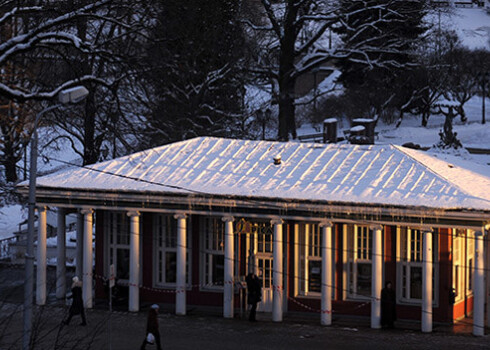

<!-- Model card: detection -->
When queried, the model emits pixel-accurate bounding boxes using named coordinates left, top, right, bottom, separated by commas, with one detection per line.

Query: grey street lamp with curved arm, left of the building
left=22, top=86, right=89, bottom=350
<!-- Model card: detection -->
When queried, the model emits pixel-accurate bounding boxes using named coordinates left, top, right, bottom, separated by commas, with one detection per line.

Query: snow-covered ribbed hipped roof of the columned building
left=38, top=137, right=490, bottom=210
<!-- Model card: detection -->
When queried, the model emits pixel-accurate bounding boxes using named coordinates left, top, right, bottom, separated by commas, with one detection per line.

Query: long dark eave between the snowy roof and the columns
left=18, top=186, right=490, bottom=230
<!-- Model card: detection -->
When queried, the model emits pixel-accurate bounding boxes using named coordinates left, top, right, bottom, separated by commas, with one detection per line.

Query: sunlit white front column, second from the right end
left=422, top=230, right=433, bottom=333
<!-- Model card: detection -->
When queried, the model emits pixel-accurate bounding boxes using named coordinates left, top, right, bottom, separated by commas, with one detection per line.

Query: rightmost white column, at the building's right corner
left=473, top=230, right=485, bottom=336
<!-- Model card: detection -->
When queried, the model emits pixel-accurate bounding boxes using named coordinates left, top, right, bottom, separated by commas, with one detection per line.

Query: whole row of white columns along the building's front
left=36, top=207, right=488, bottom=336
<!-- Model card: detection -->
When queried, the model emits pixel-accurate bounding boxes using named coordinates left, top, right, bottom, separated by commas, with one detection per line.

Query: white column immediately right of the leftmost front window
left=127, top=211, right=141, bottom=312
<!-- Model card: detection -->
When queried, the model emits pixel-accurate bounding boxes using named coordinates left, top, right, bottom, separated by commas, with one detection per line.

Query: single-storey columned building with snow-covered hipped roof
left=16, top=137, right=490, bottom=335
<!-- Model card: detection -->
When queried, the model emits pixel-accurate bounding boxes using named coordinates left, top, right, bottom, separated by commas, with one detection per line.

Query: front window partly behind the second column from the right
left=397, top=227, right=438, bottom=303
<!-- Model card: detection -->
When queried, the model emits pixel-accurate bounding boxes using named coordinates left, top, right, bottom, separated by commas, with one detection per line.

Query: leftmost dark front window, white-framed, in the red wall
left=105, top=212, right=129, bottom=282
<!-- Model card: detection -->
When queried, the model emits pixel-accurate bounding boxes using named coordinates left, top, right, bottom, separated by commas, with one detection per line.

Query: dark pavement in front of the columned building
left=0, top=265, right=490, bottom=350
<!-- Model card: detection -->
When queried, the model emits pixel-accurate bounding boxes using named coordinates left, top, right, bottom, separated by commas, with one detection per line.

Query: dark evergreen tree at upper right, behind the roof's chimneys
left=337, top=0, right=427, bottom=121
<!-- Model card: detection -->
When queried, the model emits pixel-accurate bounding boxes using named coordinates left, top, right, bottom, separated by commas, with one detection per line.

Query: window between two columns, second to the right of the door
left=344, top=225, right=373, bottom=299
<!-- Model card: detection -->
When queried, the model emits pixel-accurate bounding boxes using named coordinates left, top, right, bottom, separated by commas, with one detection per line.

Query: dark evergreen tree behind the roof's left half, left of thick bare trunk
left=147, top=0, right=244, bottom=145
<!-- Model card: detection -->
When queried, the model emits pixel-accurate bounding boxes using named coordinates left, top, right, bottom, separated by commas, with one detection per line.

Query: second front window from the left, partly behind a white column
left=153, top=214, right=191, bottom=287
